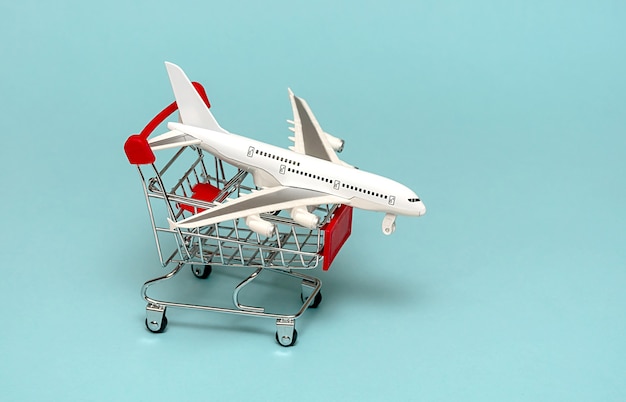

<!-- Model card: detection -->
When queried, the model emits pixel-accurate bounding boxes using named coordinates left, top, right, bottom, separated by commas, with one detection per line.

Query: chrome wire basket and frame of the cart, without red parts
left=133, top=147, right=337, bottom=346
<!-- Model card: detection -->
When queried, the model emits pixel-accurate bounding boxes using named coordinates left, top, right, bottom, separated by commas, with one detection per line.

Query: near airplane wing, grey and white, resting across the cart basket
left=170, top=186, right=347, bottom=228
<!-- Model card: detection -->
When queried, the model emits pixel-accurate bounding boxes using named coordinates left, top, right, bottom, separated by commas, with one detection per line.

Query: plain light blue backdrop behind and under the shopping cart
left=0, top=0, right=626, bottom=401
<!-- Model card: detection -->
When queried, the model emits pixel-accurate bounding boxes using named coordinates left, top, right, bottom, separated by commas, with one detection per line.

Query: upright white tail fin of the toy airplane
left=165, top=62, right=228, bottom=133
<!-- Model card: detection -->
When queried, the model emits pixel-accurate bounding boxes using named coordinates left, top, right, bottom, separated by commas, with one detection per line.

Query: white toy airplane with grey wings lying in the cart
left=149, top=63, right=426, bottom=237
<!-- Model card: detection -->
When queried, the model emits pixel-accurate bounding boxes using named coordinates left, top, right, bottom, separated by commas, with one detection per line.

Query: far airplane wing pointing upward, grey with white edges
left=289, top=90, right=344, bottom=165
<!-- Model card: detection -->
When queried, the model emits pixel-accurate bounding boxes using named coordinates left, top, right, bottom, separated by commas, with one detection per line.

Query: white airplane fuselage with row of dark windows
left=168, top=123, right=426, bottom=218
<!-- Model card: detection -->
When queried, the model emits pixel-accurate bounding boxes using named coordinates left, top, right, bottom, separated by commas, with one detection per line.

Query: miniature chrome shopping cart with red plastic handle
left=124, top=89, right=352, bottom=346
